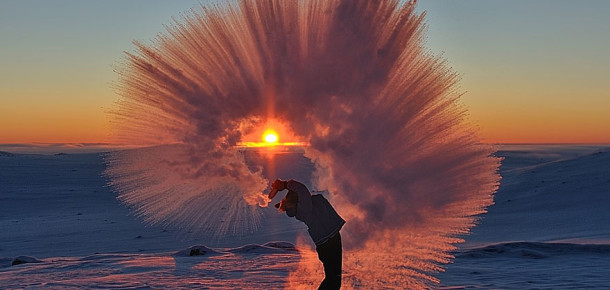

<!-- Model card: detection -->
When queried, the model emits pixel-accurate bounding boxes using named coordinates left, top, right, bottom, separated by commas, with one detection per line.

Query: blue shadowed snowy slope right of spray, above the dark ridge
left=467, top=146, right=610, bottom=244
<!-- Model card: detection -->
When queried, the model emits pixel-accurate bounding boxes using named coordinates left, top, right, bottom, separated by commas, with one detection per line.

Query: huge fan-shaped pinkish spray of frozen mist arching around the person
left=107, top=0, right=500, bottom=287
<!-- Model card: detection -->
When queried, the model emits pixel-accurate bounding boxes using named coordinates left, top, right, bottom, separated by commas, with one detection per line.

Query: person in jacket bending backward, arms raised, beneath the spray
left=268, top=179, right=345, bottom=289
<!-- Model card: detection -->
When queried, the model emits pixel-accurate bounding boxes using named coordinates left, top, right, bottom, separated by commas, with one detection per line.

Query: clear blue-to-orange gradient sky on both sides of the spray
left=0, top=0, right=610, bottom=143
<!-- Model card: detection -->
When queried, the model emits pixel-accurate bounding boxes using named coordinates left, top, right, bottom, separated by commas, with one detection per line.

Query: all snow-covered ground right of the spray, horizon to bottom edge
left=438, top=145, right=610, bottom=289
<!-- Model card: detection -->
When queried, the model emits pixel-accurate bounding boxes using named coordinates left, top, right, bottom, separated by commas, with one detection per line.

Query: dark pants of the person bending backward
left=316, top=233, right=343, bottom=289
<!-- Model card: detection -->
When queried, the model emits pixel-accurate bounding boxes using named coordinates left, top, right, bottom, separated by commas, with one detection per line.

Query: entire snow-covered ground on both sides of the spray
left=0, top=145, right=610, bottom=289
